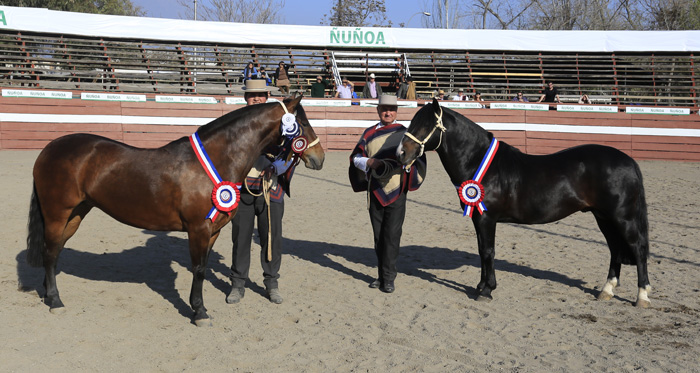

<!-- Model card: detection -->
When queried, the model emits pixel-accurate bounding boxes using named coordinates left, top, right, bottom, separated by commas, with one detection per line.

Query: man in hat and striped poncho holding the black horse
left=349, top=95, right=426, bottom=293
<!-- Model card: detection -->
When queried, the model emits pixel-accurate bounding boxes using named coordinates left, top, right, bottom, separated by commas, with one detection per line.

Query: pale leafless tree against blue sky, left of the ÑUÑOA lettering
left=178, top=0, right=284, bottom=23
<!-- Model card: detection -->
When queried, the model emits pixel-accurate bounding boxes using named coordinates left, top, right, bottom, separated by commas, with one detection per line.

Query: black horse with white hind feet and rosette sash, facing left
left=397, top=100, right=651, bottom=307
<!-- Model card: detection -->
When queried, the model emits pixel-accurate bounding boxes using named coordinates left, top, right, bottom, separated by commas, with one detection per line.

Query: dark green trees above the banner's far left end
left=0, top=0, right=146, bottom=16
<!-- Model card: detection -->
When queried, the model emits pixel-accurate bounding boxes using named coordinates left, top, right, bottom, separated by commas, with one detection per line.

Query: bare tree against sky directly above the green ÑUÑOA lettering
left=321, top=0, right=392, bottom=27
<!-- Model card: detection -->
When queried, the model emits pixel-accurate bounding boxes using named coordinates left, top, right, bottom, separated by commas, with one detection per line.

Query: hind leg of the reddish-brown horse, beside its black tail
left=43, top=204, right=90, bottom=313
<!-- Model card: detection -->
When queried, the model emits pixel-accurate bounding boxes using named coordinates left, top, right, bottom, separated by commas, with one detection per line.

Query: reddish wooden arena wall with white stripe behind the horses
left=0, top=92, right=700, bottom=161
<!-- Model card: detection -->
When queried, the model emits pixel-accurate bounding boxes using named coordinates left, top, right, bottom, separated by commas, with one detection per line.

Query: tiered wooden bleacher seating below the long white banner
left=0, top=30, right=700, bottom=106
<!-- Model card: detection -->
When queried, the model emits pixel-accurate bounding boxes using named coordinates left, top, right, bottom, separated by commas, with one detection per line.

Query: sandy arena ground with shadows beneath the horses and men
left=0, top=151, right=700, bottom=372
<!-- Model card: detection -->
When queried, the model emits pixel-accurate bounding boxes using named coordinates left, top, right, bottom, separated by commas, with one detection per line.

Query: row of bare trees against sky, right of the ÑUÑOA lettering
left=422, top=0, right=700, bottom=30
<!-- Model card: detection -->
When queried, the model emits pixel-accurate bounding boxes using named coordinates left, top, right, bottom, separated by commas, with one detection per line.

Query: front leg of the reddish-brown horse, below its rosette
left=188, top=229, right=219, bottom=326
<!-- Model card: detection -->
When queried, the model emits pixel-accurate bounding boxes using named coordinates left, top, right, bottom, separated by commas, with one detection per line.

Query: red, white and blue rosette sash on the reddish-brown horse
left=190, top=132, right=242, bottom=221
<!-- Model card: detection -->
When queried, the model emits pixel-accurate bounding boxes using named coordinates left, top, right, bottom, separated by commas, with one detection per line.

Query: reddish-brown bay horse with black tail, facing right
left=27, top=96, right=325, bottom=326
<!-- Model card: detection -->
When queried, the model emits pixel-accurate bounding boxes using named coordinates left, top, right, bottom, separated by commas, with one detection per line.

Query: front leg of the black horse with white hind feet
left=473, top=216, right=496, bottom=301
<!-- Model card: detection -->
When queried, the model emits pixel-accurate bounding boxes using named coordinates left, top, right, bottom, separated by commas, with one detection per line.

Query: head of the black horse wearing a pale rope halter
left=396, top=99, right=445, bottom=165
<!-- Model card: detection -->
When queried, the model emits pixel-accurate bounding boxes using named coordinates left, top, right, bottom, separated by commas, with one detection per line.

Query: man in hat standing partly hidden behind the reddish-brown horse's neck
left=226, top=79, right=294, bottom=304
